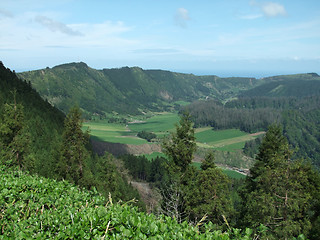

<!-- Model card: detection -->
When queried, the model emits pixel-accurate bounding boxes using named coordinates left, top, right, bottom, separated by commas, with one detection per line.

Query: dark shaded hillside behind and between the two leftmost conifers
left=0, top=62, right=64, bottom=176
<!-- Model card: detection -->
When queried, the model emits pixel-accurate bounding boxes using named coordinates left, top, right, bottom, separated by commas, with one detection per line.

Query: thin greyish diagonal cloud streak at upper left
left=35, top=15, right=83, bottom=36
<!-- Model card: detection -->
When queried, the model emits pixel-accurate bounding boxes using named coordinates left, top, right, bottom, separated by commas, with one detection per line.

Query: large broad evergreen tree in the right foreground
left=241, top=125, right=316, bottom=239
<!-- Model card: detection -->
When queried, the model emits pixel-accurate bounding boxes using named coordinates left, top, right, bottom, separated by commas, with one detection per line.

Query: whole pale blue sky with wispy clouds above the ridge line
left=0, top=0, right=320, bottom=77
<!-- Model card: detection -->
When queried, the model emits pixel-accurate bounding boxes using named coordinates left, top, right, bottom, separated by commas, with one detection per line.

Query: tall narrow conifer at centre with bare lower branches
left=161, top=112, right=196, bottom=221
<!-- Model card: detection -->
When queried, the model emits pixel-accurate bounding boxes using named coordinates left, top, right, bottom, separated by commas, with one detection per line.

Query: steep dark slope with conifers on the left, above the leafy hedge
left=0, top=61, right=144, bottom=208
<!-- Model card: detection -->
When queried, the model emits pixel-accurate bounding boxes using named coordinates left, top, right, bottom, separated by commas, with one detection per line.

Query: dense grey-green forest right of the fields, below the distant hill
left=186, top=96, right=320, bottom=167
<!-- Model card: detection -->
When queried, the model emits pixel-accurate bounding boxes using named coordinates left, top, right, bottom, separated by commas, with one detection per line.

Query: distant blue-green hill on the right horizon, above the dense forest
left=239, top=73, right=320, bottom=97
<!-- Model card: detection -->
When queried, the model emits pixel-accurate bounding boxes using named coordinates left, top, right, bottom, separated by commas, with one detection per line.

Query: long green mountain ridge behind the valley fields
left=18, top=63, right=261, bottom=114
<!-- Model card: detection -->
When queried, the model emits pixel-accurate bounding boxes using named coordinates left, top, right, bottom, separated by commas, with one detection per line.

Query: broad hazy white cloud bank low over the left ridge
left=0, top=12, right=137, bottom=52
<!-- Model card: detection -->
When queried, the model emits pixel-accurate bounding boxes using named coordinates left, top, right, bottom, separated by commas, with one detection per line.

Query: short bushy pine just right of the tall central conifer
left=185, top=153, right=233, bottom=226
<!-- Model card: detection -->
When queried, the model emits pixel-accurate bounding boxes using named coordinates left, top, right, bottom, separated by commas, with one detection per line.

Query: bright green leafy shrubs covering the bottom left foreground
left=0, top=166, right=270, bottom=240
